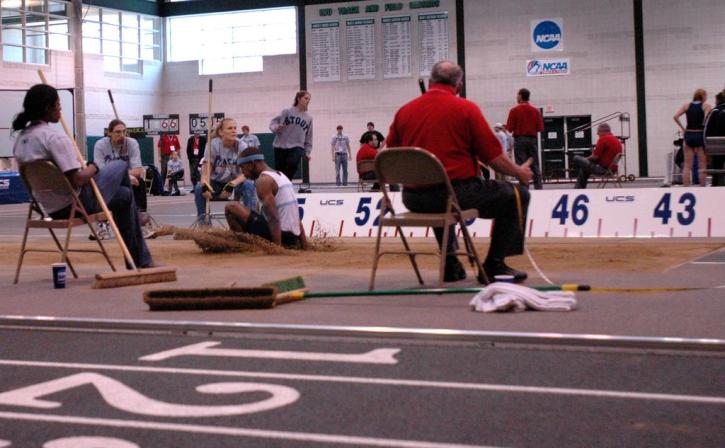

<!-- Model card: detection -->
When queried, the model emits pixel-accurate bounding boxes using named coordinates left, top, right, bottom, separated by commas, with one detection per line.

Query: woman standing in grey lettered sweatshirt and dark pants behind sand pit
left=269, top=90, right=312, bottom=180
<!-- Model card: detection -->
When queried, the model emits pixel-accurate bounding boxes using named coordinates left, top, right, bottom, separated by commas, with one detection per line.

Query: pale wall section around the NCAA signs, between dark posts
left=464, top=0, right=638, bottom=173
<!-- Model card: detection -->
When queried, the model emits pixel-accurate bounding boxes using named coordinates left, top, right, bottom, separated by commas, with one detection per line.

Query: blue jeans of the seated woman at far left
left=80, top=160, right=153, bottom=268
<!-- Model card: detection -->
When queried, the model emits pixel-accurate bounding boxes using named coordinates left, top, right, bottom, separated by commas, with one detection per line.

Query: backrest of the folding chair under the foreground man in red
left=375, top=147, right=450, bottom=186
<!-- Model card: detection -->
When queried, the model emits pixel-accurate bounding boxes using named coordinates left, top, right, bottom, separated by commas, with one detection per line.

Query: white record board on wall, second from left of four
left=345, top=19, right=375, bottom=80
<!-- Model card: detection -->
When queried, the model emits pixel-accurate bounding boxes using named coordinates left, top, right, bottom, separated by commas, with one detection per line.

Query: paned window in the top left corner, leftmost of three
left=0, top=0, right=70, bottom=64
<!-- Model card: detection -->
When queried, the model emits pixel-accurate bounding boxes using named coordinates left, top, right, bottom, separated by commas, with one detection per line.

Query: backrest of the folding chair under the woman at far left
left=20, top=160, right=75, bottom=216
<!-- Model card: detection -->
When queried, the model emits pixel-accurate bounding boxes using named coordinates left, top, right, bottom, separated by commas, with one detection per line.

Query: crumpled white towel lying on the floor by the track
left=470, top=282, right=577, bottom=313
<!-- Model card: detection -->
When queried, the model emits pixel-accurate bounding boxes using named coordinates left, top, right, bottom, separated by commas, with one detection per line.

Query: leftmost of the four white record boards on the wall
left=311, top=21, right=340, bottom=82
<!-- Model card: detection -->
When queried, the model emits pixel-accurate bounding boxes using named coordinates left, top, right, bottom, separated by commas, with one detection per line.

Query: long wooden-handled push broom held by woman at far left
left=38, top=70, right=176, bottom=289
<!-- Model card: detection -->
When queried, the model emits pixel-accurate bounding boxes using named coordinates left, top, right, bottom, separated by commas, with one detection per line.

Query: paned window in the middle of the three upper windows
left=83, top=6, right=161, bottom=73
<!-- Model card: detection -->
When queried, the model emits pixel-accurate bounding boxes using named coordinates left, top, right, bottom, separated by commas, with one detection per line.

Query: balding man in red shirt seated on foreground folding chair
left=387, top=61, right=532, bottom=281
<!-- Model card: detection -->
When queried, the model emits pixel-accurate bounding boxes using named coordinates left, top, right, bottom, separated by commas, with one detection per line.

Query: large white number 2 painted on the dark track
left=0, top=372, right=300, bottom=417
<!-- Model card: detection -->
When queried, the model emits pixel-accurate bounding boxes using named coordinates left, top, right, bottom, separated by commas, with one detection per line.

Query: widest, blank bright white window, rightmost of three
left=167, top=7, right=297, bottom=75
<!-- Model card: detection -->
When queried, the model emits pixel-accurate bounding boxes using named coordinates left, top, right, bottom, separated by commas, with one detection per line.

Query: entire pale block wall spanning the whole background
left=0, top=0, right=725, bottom=182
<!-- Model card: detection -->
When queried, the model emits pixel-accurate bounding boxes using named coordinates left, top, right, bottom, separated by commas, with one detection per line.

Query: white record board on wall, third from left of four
left=382, top=16, right=413, bottom=79
